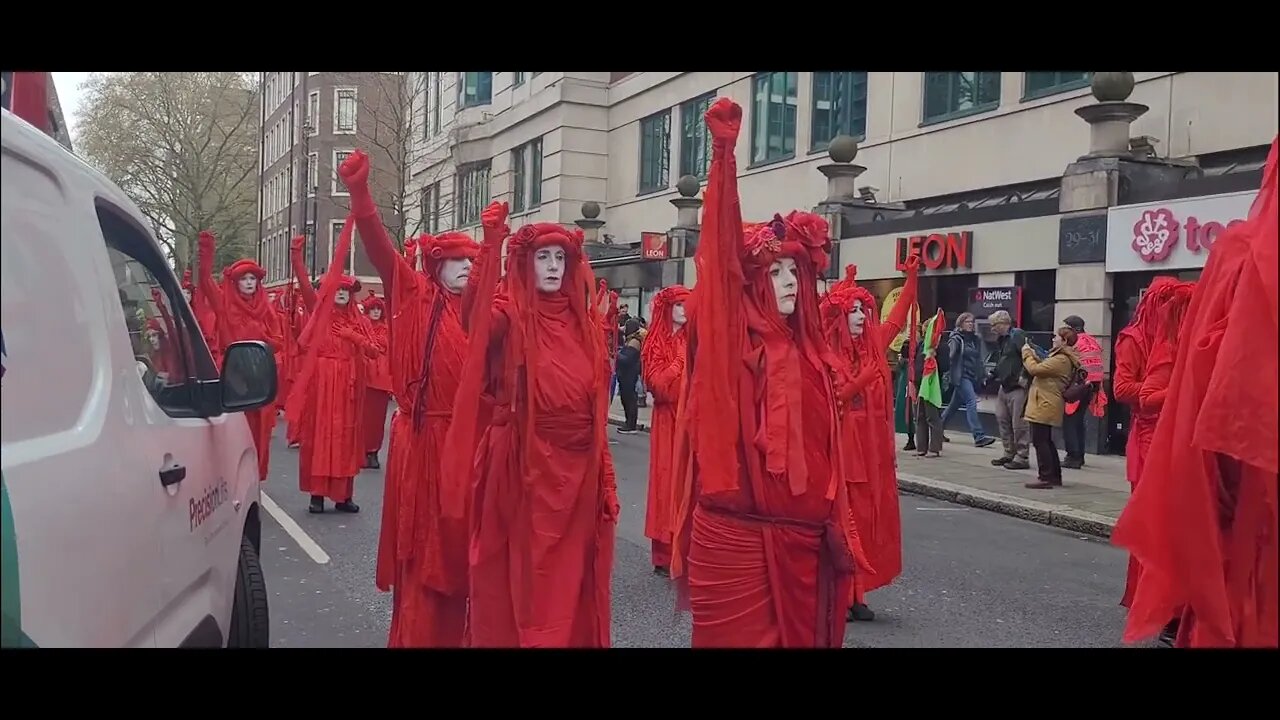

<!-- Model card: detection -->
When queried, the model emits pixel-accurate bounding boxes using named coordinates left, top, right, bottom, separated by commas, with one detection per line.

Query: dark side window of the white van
left=97, top=202, right=218, bottom=418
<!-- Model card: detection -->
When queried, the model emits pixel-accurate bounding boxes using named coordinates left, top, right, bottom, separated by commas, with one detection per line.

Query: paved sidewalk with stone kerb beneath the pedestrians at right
left=609, top=398, right=1129, bottom=538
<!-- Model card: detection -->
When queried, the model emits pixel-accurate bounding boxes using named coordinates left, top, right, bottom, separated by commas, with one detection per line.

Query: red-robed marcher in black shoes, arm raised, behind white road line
left=285, top=217, right=387, bottom=512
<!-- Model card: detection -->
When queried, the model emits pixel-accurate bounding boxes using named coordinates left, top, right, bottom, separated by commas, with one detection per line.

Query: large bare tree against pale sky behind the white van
left=77, top=72, right=259, bottom=273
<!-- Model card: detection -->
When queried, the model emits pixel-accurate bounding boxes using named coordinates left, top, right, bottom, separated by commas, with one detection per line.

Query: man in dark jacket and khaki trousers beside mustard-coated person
left=987, top=310, right=1032, bottom=470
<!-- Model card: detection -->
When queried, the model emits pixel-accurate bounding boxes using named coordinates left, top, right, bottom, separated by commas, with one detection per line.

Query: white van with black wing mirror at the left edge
left=0, top=99, right=275, bottom=647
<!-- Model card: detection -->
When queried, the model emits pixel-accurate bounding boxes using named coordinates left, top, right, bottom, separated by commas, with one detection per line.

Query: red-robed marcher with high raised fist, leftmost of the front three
left=338, top=150, right=480, bottom=647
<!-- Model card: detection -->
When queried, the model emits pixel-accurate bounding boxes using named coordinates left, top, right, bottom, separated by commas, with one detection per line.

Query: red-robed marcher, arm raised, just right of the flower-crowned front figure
left=822, top=254, right=920, bottom=621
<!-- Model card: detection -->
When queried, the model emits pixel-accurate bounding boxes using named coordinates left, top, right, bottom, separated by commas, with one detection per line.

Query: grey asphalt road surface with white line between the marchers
left=262, top=407, right=1126, bottom=647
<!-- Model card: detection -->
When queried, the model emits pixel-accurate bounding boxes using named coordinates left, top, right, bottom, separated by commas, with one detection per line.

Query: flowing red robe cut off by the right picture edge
left=1111, top=135, right=1280, bottom=648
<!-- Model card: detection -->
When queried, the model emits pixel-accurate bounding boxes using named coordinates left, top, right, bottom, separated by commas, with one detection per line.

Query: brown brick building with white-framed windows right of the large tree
left=259, top=72, right=407, bottom=293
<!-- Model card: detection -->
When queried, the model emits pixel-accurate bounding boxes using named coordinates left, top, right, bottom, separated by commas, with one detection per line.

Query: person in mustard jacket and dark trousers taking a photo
left=1023, top=327, right=1080, bottom=489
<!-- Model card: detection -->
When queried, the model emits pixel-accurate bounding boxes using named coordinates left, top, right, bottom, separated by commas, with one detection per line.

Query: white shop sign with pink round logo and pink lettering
left=1107, top=191, right=1258, bottom=273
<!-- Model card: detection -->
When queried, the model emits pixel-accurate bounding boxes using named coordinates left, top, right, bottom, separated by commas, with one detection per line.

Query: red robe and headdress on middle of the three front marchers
left=445, top=215, right=618, bottom=647
